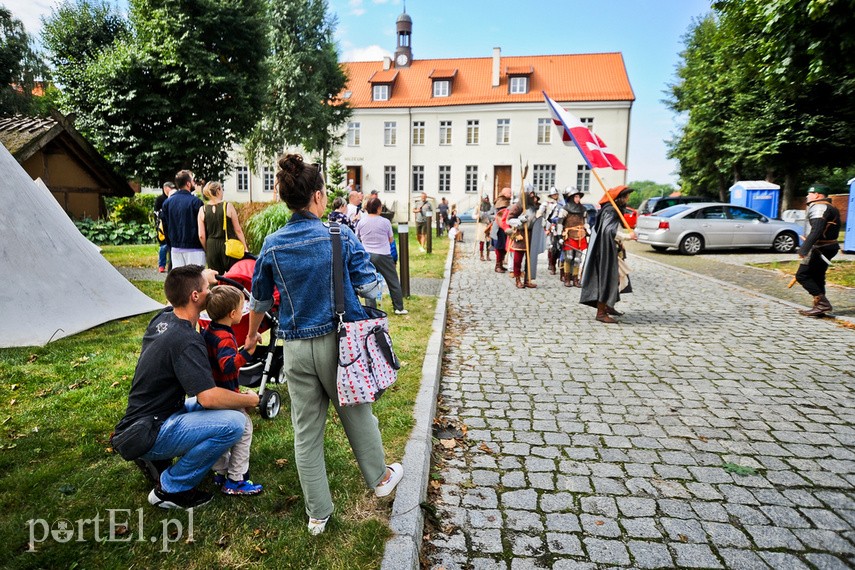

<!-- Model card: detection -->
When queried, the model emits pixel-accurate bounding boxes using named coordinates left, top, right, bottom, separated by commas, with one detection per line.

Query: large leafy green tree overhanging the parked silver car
left=668, top=0, right=855, bottom=208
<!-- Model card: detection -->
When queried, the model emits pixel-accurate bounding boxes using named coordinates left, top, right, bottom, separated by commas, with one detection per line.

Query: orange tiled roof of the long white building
left=342, top=53, right=635, bottom=109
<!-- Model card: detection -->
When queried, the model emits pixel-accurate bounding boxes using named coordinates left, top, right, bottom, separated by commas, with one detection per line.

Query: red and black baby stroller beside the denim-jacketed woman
left=199, top=256, right=285, bottom=419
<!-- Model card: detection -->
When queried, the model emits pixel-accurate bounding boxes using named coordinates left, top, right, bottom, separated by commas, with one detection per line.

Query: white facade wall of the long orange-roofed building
left=224, top=101, right=631, bottom=221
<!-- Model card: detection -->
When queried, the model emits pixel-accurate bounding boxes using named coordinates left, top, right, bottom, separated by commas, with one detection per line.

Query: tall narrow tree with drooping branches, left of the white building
left=245, top=0, right=352, bottom=171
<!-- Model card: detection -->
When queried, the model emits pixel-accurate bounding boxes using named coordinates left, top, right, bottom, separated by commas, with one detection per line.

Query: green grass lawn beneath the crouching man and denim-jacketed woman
left=0, top=246, right=438, bottom=570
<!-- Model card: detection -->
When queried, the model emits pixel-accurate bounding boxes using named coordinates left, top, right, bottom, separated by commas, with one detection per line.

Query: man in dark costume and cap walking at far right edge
left=796, top=185, right=840, bottom=317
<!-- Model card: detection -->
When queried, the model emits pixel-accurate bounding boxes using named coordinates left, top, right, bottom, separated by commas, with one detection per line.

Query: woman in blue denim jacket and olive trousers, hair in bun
left=241, top=154, right=404, bottom=535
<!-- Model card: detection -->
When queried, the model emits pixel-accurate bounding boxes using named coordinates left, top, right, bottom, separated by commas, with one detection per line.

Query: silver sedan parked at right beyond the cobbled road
left=635, top=202, right=804, bottom=255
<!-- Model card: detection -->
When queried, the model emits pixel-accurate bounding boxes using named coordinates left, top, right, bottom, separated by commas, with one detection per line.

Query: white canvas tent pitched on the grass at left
left=0, top=145, right=163, bottom=348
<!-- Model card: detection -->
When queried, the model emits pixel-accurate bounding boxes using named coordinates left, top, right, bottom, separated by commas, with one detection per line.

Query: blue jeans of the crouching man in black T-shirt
left=142, top=398, right=246, bottom=493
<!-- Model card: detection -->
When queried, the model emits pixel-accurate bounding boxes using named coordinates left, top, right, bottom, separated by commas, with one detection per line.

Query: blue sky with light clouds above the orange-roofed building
left=11, top=0, right=710, bottom=184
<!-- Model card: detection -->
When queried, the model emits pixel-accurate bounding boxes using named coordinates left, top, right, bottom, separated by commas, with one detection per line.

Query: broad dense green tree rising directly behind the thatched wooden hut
left=45, top=0, right=267, bottom=185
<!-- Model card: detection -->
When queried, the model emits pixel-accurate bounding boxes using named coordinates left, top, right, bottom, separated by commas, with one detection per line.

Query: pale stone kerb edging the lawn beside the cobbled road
left=380, top=240, right=456, bottom=570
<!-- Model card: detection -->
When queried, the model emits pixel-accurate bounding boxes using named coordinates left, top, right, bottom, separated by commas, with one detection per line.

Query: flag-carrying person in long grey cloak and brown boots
left=579, top=186, right=635, bottom=323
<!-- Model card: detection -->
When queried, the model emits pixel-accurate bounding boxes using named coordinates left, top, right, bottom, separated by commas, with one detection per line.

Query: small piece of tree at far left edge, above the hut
left=0, top=5, right=47, bottom=116
